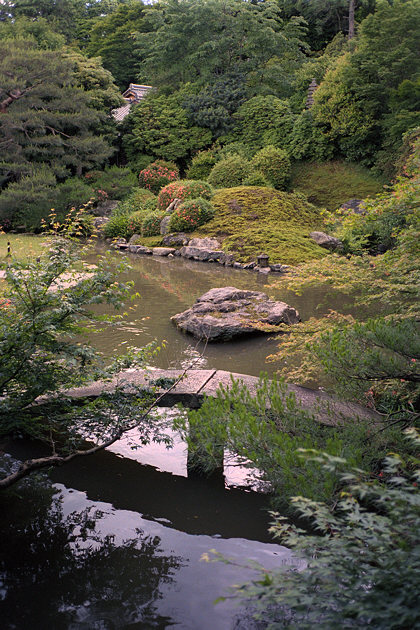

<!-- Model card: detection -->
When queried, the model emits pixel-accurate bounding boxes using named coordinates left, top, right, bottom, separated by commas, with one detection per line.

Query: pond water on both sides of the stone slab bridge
left=0, top=249, right=352, bottom=630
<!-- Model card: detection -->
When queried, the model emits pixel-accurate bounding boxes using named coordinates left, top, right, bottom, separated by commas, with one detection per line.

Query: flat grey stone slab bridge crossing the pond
left=67, top=368, right=380, bottom=424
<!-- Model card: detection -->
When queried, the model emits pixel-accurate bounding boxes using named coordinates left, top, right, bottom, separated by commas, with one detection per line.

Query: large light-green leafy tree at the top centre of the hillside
left=137, top=0, right=304, bottom=94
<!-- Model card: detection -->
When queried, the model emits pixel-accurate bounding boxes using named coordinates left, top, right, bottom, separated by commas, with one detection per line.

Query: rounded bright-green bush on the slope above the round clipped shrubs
left=234, top=96, right=294, bottom=152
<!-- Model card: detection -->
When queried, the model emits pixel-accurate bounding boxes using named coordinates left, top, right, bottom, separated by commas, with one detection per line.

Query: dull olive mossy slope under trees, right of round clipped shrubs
left=290, top=161, right=385, bottom=210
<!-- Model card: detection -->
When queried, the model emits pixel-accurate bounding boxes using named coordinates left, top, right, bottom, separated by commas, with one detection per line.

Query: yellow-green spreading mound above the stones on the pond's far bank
left=200, top=186, right=326, bottom=265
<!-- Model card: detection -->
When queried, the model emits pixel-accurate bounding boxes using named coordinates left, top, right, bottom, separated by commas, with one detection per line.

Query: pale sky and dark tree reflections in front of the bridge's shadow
left=0, top=483, right=293, bottom=630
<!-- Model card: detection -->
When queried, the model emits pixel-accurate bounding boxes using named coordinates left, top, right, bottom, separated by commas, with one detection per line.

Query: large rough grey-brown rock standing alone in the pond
left=171, top=287, right=300, bottom=341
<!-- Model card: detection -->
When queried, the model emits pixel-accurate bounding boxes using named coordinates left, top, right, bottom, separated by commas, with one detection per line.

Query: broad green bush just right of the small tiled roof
left=123, top=94, right=211, bottom=163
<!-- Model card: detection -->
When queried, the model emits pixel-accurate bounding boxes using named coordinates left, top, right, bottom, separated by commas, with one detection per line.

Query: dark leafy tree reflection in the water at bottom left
left=0, top=488, right=182, bottom=630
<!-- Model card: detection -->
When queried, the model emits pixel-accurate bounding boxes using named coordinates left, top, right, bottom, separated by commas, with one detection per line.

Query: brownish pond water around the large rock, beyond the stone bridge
left=84, top=246, right=352, bottom=376
